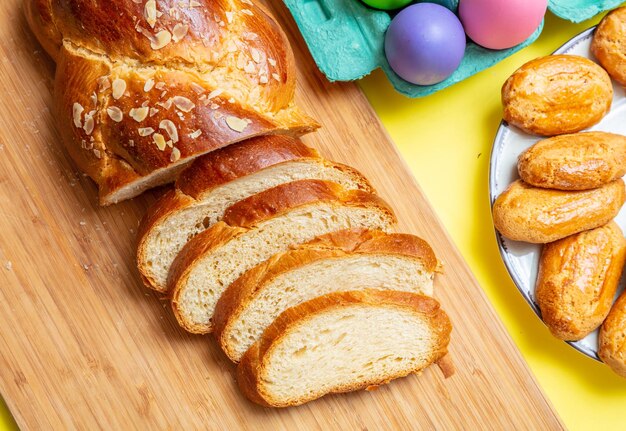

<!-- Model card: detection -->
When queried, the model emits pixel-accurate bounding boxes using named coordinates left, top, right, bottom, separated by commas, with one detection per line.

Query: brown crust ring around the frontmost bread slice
left=237, top=290, right=452, bottom=407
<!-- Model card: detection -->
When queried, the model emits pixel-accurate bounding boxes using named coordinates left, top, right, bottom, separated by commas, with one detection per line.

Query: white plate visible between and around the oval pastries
left=489, top=28, right=626, bottom=360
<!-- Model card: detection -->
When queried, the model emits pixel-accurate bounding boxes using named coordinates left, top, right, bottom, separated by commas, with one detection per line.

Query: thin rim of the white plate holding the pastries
left=489, top=25, right=602, bottom=362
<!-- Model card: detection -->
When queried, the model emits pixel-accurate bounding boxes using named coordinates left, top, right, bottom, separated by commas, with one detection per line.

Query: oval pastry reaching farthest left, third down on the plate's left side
left=493, top=179, right=626, bottom=244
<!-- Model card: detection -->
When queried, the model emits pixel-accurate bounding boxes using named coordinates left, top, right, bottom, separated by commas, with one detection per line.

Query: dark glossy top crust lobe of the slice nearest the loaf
left=176, top=135, right=320, bottom=199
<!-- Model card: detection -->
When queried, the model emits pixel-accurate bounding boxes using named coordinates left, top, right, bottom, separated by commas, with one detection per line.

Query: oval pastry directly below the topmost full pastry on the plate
left=517, top=132, right=626, bottom=190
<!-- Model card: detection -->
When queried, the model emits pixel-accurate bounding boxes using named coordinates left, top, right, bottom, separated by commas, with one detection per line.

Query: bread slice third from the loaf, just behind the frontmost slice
left=213, top=229, right=437, bottom=362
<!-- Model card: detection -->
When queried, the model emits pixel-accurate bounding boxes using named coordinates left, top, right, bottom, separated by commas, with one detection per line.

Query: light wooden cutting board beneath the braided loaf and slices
left=0, top=0, right=563, bottom=430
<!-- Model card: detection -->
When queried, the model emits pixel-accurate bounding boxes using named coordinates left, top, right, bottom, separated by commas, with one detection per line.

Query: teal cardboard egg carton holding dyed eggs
left=284, top=0, right=623, bottom=97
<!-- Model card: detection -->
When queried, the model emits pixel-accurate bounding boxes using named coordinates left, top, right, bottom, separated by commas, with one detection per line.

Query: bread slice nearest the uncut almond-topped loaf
left=137, top=136, right=372, bottom=292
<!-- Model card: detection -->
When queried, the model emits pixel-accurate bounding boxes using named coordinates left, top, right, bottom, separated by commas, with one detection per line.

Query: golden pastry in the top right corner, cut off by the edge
left=591, top=7, right=626, bottom=85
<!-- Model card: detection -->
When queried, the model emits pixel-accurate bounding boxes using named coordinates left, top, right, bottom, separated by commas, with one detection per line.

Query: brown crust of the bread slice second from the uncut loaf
left=167, top=180, right=396, bottom=333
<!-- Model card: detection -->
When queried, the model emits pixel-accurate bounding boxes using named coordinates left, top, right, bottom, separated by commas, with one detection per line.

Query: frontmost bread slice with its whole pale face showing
left=237, top=290, right=452, bottom=407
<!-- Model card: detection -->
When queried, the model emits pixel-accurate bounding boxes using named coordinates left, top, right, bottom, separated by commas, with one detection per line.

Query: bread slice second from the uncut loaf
left=168, top=180, right=395, bottom=333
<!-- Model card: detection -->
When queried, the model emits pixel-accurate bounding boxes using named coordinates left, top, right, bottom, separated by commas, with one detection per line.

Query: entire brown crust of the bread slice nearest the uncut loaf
left=136, top=136, right=374, bottom=292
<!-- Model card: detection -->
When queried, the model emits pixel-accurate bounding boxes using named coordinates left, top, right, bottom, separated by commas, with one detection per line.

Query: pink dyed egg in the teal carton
left=459, top=0, right=548, bottom=49
